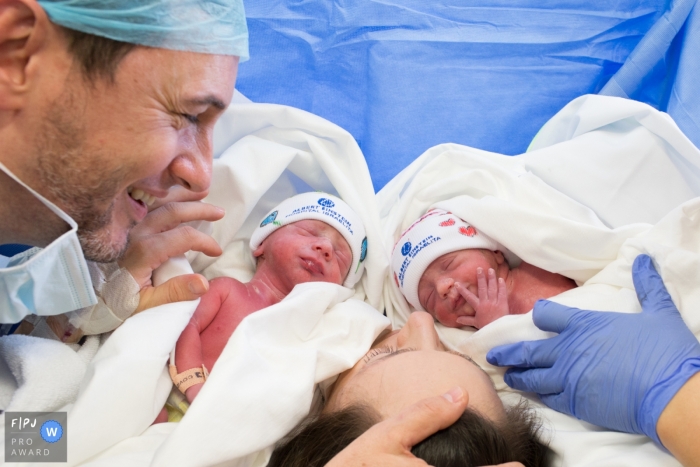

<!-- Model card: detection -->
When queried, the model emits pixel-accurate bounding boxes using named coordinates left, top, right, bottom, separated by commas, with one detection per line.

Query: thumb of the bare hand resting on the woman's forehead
left=370, top=386, right=469, bottom=450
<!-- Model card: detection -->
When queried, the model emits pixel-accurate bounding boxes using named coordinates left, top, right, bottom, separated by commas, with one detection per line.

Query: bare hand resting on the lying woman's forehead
left=326, top=387, right=469, bottom=467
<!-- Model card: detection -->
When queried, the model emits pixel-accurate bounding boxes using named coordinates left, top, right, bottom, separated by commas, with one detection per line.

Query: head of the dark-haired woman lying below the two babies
left=268, top=312, right=548, bottom=467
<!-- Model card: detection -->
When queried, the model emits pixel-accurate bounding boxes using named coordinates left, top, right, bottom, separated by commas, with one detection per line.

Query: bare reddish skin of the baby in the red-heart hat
left=418, top=249, right=576, bottom=329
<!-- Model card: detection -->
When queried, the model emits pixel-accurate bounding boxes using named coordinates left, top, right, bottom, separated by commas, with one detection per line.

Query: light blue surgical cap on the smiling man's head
left=39, top=0, right=248, bottom=61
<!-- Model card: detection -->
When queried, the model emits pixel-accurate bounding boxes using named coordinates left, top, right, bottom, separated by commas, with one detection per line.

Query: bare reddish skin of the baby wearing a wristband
left=175, top=220, right=352, bottom=402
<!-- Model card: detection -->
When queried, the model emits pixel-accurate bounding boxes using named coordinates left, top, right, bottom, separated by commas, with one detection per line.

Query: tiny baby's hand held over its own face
left=455, top=268, right=508, bottom=329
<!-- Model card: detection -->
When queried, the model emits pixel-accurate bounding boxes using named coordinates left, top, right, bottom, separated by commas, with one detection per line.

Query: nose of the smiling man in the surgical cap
left=168, top=132, right=213, bottom=193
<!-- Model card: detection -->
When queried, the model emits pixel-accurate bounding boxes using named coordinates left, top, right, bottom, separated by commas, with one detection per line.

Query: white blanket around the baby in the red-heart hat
left=378, top=96, right=700, bottom=466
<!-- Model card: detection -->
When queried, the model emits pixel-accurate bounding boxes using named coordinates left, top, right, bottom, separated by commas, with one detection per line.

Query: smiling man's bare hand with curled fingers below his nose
left=119, top=201, right=224, bottom=312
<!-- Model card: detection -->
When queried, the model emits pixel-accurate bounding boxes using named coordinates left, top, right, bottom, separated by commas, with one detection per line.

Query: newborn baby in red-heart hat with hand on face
left=392, top=209, right=576, bottom=329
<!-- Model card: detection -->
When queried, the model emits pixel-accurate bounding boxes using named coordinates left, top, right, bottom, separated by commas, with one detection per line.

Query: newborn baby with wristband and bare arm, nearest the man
left=170, top=193, right=367, bottom=406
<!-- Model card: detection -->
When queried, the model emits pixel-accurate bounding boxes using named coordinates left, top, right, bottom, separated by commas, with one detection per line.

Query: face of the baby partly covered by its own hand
left=418, top=249, right=503, bottom=327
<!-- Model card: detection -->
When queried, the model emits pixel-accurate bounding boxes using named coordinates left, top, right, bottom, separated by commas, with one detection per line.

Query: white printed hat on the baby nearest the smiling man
left=250, top=192, right=367, bottom=288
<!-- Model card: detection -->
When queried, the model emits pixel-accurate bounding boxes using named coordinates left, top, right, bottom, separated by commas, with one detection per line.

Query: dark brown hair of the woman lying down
left=267, top=401, right=549, bottom=467
